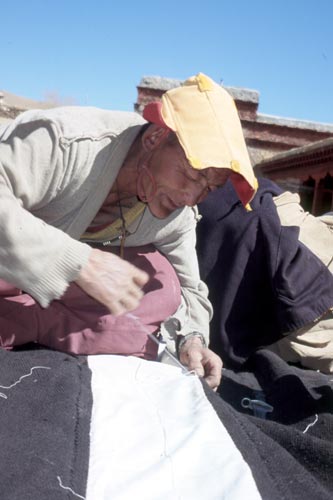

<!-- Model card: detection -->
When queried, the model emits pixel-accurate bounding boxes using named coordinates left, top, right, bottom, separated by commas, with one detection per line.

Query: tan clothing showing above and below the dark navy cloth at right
left=270, top=192, right=333, bottom=373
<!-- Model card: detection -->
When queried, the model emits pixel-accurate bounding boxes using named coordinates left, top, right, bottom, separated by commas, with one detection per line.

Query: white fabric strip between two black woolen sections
left=86, top=355, right=261, bottom=500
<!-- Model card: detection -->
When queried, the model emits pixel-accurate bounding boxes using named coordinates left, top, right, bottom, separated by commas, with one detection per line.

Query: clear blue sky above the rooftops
left=0, top=0, right=333, bottom=123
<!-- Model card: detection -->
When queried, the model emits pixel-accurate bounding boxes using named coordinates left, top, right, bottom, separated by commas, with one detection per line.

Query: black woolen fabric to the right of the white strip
left=204, top=349, right=333, bottom=500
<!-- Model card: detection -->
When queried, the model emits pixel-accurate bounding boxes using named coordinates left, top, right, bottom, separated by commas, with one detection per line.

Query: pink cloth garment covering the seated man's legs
left=0, top=245, right=180, bottom=359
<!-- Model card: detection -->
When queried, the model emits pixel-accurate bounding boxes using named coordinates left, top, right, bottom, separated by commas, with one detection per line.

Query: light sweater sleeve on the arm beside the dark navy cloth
left=156, top=207, right=212, bottom=345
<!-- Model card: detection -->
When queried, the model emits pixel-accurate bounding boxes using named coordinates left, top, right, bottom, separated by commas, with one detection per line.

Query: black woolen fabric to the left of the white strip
left=0, top=349, right=92, bottom=500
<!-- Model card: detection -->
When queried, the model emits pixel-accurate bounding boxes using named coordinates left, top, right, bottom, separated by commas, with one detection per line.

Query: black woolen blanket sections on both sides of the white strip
left=0, top=349, right=333, bottom=500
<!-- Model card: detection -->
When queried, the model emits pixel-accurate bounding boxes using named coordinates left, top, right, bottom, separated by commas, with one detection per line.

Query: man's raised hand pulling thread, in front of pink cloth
left=75, top=249, right=149, bottom=316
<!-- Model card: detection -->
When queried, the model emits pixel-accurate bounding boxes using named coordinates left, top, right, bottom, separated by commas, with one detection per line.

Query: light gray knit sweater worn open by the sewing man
left=0, top=107, right=211, bottom=348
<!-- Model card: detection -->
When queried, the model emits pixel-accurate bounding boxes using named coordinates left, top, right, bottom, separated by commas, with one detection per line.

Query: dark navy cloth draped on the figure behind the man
left=197, top=179, right=333, bottom=367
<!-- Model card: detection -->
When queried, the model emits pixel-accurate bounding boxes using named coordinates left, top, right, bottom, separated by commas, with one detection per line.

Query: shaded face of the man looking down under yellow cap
left=141, top=141, right=230, bottom=219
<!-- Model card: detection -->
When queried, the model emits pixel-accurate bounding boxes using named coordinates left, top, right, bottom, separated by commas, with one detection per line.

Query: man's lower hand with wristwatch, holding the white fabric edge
left=179, top=336, right=223, bottom=391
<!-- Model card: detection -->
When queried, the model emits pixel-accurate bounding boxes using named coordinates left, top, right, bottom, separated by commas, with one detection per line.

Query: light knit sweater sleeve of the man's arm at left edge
left=0, top=120, right=91, bottom=307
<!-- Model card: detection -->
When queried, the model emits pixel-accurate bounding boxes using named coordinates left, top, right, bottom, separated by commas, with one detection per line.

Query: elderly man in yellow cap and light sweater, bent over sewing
left=0, top=74, right=256, bottom=387
